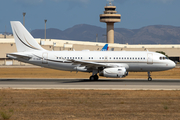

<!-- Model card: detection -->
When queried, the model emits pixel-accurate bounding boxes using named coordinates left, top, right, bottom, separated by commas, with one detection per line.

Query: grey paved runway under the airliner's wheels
left=0, top=79, right=180, bottom=90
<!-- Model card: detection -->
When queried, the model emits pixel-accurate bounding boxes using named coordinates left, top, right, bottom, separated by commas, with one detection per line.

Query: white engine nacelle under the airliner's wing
left=99, top=67, right=128, bottom=78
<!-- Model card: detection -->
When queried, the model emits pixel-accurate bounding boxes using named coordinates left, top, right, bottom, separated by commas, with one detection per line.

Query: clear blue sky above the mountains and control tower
left=0, top=0, right=180, bottom=32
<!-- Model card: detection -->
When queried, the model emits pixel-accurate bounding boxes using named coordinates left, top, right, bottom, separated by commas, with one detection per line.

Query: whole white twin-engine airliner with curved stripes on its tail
left=7, top=21, right=175, bottom=81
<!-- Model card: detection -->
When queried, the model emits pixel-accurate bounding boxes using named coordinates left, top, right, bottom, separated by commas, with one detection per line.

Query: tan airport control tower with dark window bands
left=100, top=0, right=121, bottom=43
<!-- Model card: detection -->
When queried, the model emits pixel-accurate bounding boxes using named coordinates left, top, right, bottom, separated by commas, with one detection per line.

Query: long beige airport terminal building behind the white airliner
left=0, top=36, right=180, bottom=66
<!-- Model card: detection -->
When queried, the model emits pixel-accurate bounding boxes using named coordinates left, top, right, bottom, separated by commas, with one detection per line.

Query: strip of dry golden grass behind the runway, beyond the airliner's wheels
left=0, top=68, right=180, bottom=79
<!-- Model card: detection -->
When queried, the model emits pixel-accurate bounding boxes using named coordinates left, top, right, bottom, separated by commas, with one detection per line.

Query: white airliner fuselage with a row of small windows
left=15, top=51, right=175, bottom=72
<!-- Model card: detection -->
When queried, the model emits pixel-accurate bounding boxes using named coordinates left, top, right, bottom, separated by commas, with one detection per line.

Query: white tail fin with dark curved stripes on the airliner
left=11, top=21, right=44, bottom=52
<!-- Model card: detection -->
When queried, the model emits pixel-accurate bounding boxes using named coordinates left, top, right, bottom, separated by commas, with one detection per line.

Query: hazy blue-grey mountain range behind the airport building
left=31, top=24, right=180, bottom=44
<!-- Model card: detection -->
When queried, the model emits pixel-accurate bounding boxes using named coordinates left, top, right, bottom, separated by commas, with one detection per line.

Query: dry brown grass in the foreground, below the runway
left=0, top=89, right=180, bottom=120
